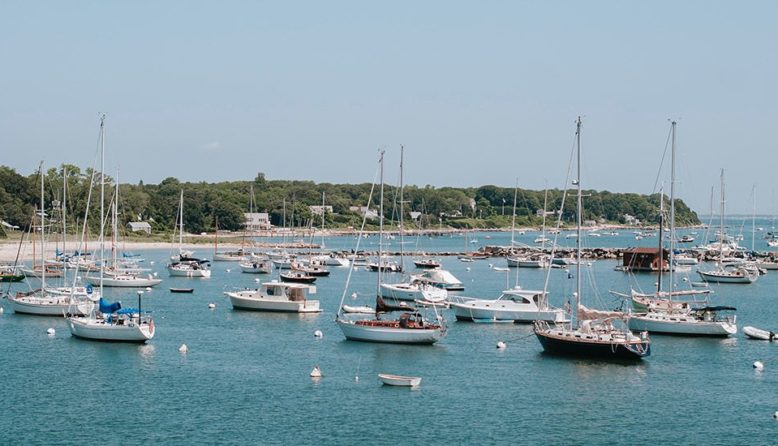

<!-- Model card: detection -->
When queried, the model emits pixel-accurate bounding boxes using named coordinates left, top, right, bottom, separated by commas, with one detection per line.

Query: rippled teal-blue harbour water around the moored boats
left=0, top=231, right=778, bottom=445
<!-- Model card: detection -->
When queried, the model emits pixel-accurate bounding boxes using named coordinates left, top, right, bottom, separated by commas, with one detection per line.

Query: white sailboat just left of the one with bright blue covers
left=8, top=163, right=88, bottom=317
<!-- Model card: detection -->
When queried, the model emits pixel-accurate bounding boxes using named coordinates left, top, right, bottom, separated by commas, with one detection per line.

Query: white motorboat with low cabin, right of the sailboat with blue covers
left=224, top=280, right=321, bottom=313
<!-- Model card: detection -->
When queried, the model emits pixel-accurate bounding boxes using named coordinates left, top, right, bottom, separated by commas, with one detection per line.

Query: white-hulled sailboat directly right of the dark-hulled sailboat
left=628, top=121, right=737, bottom=336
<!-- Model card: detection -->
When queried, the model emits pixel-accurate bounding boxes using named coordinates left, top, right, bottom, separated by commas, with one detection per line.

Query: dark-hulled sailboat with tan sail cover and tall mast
left=534, top=117, right=651, bottom=360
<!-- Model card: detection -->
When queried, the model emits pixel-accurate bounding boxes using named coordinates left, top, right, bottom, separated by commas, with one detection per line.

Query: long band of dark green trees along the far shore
left=0, top=165, right=699, bottom=237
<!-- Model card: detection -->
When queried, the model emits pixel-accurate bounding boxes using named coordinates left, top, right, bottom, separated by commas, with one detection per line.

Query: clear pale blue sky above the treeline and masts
left=0, top=0, right=778, bottom=215
